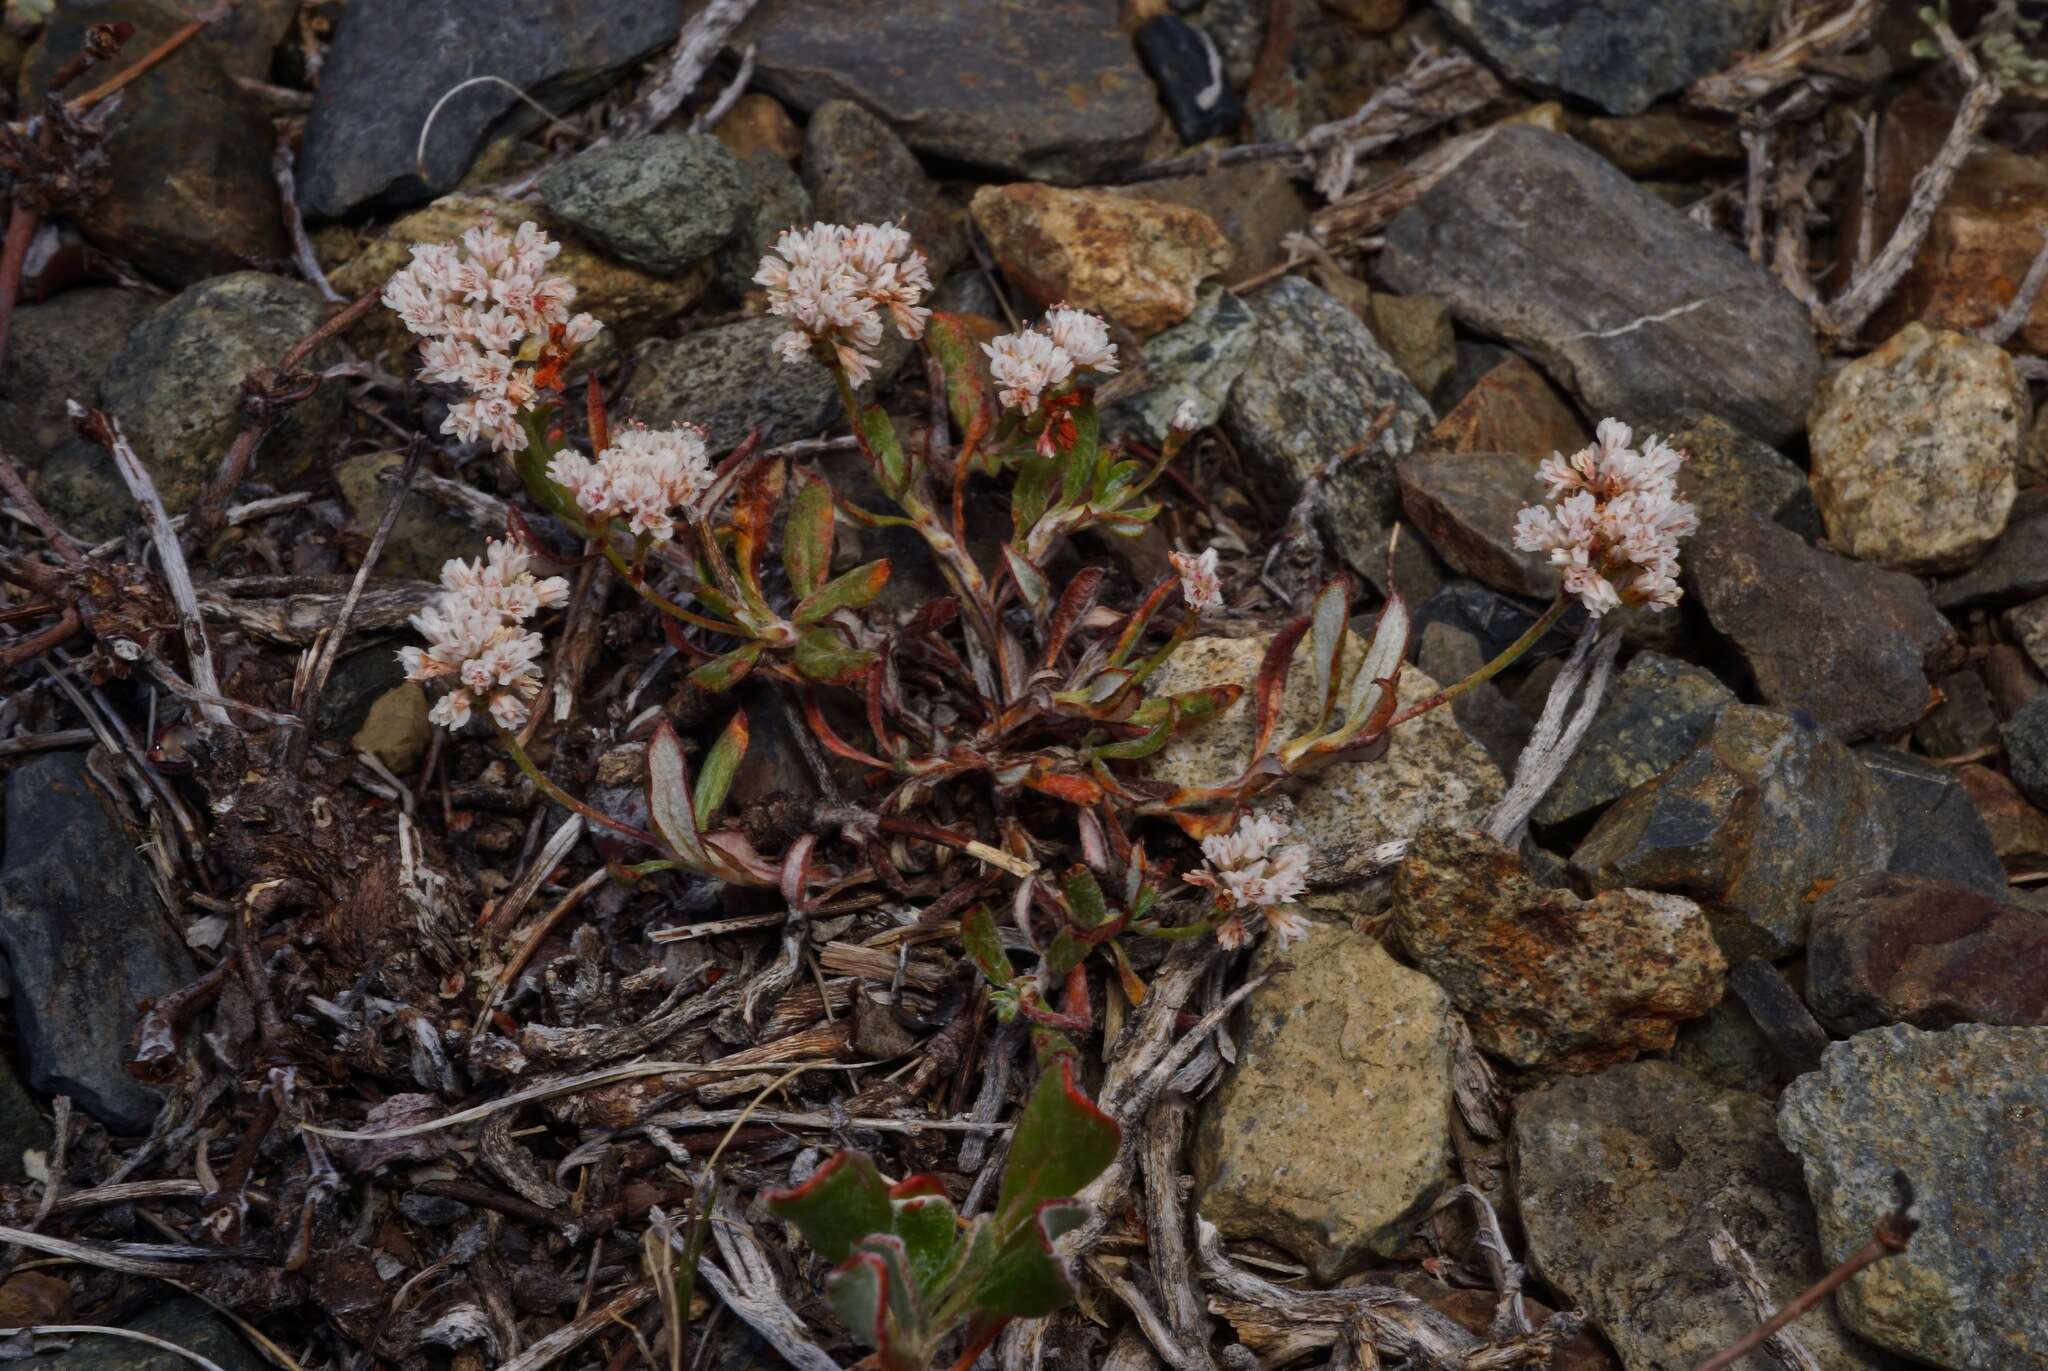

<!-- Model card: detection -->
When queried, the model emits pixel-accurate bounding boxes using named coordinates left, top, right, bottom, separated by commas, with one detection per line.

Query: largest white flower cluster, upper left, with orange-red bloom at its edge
left=383, top=223, right=602, bottom=453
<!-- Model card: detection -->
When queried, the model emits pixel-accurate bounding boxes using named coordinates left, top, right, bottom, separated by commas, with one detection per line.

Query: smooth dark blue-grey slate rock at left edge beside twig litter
left=0, top=752, right=193, bottom=1133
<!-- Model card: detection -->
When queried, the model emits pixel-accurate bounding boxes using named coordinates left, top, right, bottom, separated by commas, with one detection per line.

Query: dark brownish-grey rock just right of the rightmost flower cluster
left=1686, top=516, right=1954, bottom=738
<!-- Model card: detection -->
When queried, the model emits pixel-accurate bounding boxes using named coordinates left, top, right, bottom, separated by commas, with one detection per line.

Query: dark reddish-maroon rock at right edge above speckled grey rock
left=1806, top=873, right=2048, bottom=1033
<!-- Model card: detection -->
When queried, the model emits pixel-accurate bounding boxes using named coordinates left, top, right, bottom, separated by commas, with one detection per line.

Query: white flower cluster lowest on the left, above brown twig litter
left=397, top=541, right=569, bottom=728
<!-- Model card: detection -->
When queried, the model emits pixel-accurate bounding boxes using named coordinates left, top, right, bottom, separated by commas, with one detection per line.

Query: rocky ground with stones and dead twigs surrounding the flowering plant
left=0, top=0, right=2048, bottom=1371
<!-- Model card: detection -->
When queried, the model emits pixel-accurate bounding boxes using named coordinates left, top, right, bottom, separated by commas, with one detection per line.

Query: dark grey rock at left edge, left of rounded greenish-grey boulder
left=0, top=287, right=156, bottom=467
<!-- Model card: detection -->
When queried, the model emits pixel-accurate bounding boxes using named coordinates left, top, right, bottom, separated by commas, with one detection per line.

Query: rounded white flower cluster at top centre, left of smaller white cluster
left=754, top=223, right=932, bottom=385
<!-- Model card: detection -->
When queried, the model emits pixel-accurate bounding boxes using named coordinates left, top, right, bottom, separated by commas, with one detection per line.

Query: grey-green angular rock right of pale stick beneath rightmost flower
left=1534, top=652, right=1735, bottom=828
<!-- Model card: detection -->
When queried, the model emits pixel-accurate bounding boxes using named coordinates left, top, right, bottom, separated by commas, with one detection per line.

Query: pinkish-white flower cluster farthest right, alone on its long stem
left=1516, top=418, right=1700, bottom=615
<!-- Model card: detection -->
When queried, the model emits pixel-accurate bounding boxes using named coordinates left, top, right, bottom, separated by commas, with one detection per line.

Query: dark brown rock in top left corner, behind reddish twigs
left=23, top=0, right=288, bottom=284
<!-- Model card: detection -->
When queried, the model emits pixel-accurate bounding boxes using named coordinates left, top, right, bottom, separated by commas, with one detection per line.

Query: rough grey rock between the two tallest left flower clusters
left=633, top=318, right=840, bottom=451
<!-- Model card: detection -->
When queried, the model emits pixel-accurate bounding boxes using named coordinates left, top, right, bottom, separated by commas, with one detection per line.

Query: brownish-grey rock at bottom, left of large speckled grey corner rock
left=1511, top=1062, right=1882, bottom=1371
